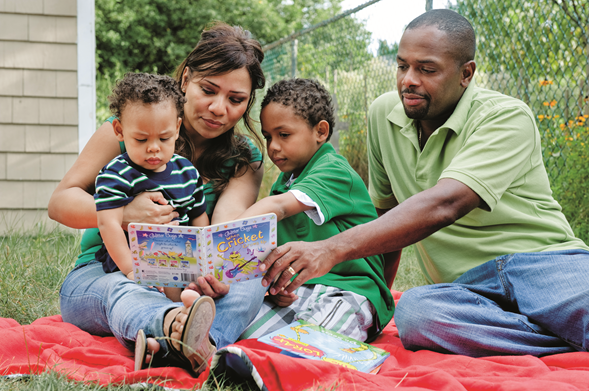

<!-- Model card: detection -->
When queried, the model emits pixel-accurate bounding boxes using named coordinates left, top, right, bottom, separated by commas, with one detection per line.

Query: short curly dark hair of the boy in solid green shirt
left=262, top=79, right=335, bottom=140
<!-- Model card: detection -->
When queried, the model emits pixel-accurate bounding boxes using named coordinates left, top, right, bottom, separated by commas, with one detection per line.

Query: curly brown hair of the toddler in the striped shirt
left=108, top=72, right=186, bottom=118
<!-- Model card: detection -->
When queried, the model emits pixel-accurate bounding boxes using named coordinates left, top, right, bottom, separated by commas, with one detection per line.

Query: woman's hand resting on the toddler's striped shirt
left=123, top=192, right=178, bottom=230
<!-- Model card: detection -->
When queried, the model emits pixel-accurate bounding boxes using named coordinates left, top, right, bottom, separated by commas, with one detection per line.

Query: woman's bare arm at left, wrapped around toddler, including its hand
left=48, top=122, right=178, bottom=228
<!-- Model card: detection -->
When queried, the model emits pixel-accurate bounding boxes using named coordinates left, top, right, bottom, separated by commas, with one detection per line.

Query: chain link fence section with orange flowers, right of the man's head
left=455, top=0, right=589, bottom=182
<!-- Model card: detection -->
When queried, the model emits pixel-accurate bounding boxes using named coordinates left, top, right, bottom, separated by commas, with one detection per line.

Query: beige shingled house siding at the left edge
left=0, top=0, right=78, bottom=235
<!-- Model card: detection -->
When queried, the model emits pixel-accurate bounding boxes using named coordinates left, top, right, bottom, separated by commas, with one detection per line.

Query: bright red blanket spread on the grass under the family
left=0, top=292, right=589, bottom=391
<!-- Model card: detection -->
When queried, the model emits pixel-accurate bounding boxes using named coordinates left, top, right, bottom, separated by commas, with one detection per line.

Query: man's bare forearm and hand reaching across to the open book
left=262, top=179, right=483, bottom=294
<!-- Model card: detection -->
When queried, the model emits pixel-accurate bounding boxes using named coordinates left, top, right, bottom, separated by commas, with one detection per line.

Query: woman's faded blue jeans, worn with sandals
left=60, top=261, right=267, bottom=353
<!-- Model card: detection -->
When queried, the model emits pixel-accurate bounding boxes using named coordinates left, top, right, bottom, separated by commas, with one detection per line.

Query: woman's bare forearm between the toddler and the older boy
left=211, top=162, right=264, bottom=224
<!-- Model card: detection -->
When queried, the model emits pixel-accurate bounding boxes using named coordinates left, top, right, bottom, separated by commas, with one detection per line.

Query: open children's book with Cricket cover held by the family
left=128, top=213, right=276, bottom=288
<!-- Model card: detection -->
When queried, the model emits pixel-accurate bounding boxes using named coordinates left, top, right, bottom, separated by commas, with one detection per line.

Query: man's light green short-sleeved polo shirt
left=367, top=84, right=589, bottom=283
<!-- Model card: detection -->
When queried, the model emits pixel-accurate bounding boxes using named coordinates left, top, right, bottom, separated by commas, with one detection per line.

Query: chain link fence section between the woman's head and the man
left=262, top=0, right=396, bottom=182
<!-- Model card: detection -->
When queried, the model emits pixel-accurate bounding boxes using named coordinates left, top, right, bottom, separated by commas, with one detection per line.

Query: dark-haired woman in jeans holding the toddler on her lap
left=49, top=23, right=266, bottom=376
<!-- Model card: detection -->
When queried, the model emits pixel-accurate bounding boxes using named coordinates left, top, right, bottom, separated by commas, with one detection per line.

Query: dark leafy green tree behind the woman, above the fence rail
left=96, top=0, right=341, bottom=122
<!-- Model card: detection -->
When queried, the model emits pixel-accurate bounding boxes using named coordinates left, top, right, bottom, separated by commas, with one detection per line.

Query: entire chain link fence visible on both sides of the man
left=263, top=0, right=589, bottom=183
